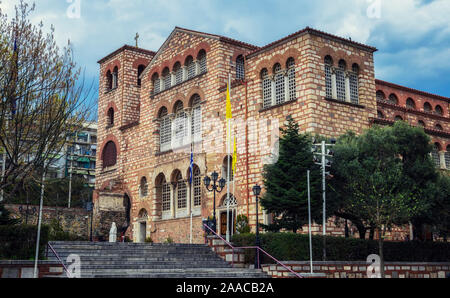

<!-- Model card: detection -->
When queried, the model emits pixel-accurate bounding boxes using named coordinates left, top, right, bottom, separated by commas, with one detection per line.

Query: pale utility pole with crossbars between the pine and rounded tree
left=313, top=139, right=336, bottom=261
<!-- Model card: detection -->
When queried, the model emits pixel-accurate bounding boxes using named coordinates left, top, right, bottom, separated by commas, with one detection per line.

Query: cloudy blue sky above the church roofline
left=0, top=0, right=450, bottom=102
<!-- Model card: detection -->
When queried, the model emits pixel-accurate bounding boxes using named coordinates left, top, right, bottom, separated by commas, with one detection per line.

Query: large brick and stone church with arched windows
left=94, top=27, right=450, bottom=243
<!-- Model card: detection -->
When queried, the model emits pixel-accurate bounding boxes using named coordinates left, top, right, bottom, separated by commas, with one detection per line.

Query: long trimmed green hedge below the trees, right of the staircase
left=232, top=233, right=450, bottom=263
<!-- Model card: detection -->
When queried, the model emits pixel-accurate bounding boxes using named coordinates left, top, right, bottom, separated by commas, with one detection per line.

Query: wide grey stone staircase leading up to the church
left=48, top=241, right=269, bottom=278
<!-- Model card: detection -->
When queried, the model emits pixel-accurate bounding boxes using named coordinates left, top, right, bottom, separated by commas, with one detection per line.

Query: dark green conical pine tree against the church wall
left=261, top=118, right=322, bottom=233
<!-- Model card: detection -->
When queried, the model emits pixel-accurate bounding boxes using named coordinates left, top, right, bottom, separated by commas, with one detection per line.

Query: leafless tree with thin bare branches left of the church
left=0, top=0, right=93, bottom=196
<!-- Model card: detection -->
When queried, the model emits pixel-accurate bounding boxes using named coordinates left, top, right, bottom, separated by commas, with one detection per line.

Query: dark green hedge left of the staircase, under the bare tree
left=0, top=225, right=49, bottom=260
